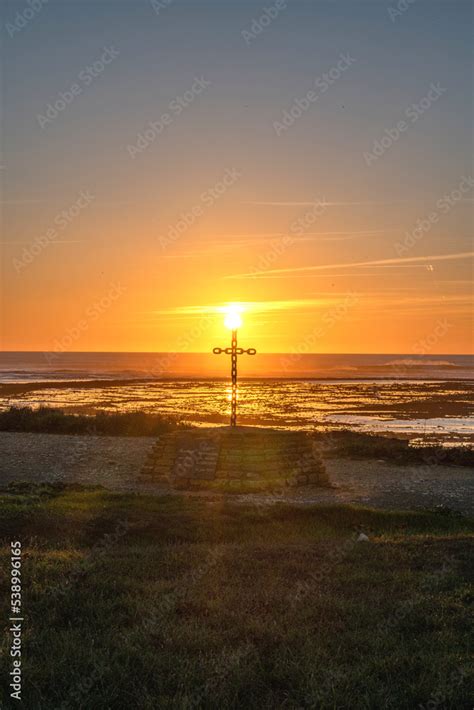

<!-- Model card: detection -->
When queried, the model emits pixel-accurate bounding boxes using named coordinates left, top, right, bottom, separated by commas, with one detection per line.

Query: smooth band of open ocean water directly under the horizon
left=0, top=352, right=474, bottom=382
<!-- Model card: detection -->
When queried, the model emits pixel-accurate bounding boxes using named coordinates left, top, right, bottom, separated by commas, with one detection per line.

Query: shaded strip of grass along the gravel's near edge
left=0, top=482, right=473, bottom=546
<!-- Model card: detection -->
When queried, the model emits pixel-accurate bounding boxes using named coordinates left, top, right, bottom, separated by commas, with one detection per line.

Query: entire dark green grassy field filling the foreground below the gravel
left=0, top=486, right=474, bottom=710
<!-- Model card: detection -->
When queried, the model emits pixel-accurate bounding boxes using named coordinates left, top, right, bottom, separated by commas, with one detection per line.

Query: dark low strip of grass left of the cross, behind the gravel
left=0, top=407, right=184, bottom=436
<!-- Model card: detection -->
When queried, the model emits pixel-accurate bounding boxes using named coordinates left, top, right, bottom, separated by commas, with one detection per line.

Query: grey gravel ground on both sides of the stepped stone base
left=0, top=432, right=474, bottom=514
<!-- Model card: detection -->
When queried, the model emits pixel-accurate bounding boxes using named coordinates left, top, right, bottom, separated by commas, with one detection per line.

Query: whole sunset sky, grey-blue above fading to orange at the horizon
left=0, top=0, right=474, bottom=355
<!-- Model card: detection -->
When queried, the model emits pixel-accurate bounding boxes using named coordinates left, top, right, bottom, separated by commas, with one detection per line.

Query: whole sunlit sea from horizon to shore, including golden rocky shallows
left=0, top=352, right=474, bottom=448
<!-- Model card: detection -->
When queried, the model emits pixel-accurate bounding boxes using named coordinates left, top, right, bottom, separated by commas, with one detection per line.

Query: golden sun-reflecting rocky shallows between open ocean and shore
left=2, top=379, right=474, bottom=448
